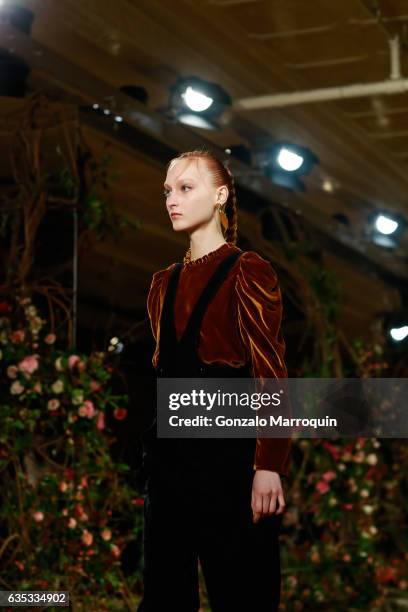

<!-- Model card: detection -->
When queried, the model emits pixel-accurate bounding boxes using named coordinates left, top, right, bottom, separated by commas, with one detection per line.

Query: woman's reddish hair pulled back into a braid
left=168, top=149, right=238, bottom=245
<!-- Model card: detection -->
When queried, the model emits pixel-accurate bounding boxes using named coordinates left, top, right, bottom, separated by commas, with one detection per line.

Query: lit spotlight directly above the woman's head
left=165, top=76, right=232, bottom=130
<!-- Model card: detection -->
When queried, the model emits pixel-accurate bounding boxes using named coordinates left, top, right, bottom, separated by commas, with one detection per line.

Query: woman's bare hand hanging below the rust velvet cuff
left=251, top=470, right=286, bottom=523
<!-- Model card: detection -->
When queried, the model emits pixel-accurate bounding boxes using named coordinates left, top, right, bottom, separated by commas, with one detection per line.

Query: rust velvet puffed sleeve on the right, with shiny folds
left=235, top=251, right=292, bottom=476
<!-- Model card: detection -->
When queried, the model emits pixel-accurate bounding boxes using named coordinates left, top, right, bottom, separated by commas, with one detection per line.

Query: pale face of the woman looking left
left=164, top=158, right=228, bottom=232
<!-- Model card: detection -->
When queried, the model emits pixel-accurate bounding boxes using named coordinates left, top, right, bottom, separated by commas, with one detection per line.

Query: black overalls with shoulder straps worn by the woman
left=138, top=252, right=282, bottom=612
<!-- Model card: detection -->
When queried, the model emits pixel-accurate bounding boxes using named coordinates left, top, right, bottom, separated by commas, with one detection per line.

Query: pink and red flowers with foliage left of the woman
left=0, top=297, right=143, bottom=600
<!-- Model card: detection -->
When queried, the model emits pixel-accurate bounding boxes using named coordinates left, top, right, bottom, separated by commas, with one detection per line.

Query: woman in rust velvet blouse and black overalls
left=138, top=151, right=291, bottom=612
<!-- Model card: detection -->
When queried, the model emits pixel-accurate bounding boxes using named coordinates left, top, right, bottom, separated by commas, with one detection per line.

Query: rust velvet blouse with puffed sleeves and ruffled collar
left=147, top=243, right=291, bottom=476
